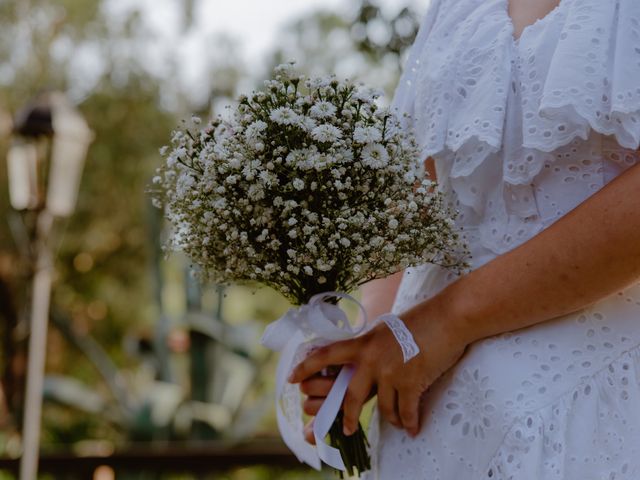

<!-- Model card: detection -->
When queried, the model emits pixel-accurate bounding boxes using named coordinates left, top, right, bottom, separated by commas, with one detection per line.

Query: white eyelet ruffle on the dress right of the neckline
left=522, top=0, right=640, bottom=151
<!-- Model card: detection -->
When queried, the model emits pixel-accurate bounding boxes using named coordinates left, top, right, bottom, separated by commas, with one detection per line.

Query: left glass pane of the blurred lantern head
left=7, top=138, right=38, bottom=210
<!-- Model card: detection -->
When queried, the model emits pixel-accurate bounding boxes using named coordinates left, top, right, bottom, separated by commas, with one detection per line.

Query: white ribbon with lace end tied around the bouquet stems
left=261, top=292, right=420, bottom=471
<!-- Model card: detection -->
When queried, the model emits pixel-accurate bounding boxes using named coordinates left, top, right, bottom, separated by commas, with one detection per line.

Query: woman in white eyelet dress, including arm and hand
left=291, top=0, right=640, bottom=480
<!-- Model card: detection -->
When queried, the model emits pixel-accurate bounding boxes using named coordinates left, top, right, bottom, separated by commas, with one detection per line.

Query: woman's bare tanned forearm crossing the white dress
left=403, top=165, right=640, bottom=343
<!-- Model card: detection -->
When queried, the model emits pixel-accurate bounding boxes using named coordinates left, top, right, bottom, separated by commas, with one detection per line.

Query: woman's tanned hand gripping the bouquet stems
left=289, top=297, right=468, bottom=436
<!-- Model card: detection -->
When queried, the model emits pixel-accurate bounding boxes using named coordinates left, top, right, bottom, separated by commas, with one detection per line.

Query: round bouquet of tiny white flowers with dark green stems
left=154, top=64, right=461, bottom=473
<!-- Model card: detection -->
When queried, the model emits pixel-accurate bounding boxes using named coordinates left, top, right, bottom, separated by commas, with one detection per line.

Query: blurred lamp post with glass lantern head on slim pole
left=7, top=92, right=93, bottom=480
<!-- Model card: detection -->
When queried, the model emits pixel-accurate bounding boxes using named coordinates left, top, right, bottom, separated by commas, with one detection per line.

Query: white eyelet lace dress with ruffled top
left=365, top=0, right=640, bottom=480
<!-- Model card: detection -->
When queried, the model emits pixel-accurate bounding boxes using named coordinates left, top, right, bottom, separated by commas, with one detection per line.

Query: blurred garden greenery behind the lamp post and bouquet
left=0, top=0, right=418, bottom=472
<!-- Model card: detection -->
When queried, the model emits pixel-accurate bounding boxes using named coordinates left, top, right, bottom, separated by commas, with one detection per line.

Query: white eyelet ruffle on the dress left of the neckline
left=393, top=0, right=510, bottom=163
